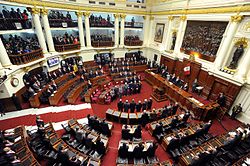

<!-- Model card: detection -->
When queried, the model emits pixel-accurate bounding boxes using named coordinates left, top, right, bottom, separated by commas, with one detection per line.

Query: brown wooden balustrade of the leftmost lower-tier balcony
left=9, top=48, right=43, bottom=65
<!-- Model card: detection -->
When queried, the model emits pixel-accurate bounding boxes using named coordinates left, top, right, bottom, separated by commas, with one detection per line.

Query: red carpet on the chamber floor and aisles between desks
left=0, top=81, right=240, bottom=166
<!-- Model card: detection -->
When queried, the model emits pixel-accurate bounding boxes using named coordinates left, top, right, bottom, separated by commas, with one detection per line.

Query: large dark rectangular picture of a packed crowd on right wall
left=182, top=22, right=227, bottom=57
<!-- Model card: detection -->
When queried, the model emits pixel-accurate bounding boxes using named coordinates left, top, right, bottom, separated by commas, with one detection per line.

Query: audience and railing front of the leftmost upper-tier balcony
left=0, top=6, right=32, bottom=30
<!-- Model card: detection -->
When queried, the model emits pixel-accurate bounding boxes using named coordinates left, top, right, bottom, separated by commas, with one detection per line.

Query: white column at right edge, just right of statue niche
left=237, top=46, right=250, bottom=80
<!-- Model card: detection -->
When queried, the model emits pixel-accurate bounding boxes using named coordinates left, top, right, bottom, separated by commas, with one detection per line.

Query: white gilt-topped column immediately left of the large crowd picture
left=174, top=16, right=187, bottom=55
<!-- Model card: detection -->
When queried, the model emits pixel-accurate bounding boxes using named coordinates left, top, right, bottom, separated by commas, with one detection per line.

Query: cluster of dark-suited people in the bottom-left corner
left=0, top=131, right=21, bottom=166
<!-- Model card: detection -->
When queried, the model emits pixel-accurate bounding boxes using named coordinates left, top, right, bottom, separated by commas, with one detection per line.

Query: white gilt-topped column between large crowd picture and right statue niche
left=214, top=15, right=243, bottom=69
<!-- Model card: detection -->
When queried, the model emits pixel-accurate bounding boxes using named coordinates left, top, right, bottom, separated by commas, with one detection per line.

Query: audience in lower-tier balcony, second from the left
left=53, top=32, right=79, bottom=45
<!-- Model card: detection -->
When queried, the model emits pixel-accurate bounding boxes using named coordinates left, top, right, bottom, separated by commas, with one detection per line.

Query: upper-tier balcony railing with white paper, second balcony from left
left=49, top=19, right=78, bottom=28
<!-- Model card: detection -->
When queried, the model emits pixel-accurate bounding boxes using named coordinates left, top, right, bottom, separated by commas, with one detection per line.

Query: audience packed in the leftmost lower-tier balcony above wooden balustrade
left=1, top=35, right=40, bottom=55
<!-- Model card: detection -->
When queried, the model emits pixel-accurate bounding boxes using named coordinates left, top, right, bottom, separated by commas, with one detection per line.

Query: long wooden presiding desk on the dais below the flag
left=145, top=70, right=218, bottom=120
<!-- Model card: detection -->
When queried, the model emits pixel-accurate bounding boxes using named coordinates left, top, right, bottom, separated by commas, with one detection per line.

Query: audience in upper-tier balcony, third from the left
left=89, top=14, right=114, bottom=27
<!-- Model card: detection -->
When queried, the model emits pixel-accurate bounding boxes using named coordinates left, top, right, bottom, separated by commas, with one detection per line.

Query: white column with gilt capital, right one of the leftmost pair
left=42, top=9, right=55, bottom=52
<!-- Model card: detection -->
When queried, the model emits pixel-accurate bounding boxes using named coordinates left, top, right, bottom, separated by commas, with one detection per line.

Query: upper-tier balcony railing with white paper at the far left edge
left=0, top=18, right=32, bottom=30
